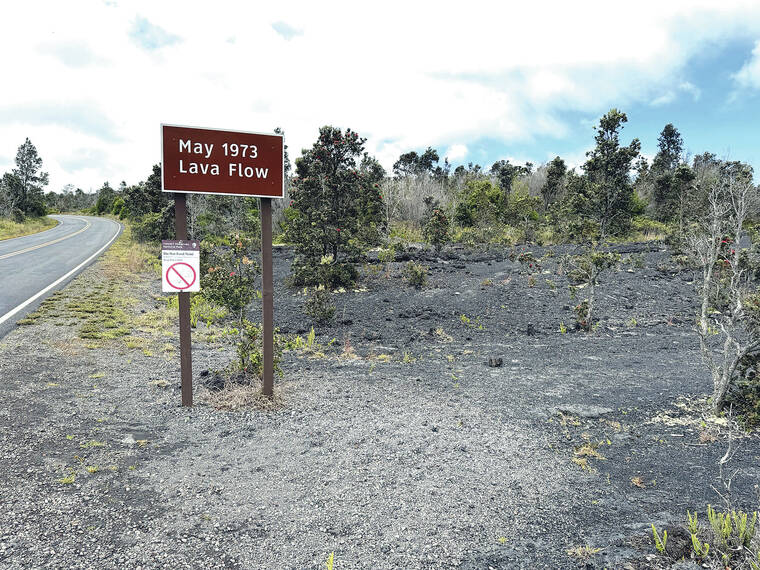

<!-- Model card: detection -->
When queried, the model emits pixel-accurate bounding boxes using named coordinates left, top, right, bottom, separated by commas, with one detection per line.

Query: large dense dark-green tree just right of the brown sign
left=287, top=126, right=383, bottom=286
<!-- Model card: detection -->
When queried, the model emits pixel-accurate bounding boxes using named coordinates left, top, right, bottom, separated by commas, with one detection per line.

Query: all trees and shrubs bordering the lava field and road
left=0, top=109, right=760, bottom=426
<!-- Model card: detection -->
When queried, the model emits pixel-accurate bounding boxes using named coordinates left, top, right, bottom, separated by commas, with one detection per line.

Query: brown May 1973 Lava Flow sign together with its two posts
left=161, top=125, right=285, bottom=406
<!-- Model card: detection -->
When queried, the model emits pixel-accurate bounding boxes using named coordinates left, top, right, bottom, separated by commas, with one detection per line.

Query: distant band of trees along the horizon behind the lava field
left=0, top=109, right=753, bottom=243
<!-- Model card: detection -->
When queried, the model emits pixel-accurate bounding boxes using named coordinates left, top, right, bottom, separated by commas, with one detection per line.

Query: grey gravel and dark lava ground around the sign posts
left=0, top=237, right=760, bottom=569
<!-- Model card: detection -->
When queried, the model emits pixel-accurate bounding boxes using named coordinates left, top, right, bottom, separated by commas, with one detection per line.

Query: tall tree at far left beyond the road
left=4, top=138, right=48, bottom=216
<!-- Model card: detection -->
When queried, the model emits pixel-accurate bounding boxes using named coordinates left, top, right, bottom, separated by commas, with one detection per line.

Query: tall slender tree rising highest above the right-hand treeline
left=583, top=108, right=641, bottom=239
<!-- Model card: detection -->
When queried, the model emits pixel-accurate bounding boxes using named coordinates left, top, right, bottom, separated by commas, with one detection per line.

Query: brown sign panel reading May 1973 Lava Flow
left=161, top=125, right=284, bottom=198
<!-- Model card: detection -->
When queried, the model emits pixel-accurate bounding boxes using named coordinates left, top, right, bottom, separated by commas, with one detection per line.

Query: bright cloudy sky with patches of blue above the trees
left=0, top=0, right=760, bottom=191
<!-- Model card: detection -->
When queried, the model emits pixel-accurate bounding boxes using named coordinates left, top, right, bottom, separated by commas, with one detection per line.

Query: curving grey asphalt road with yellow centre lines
left=0, top=215, right=121, bottom=338
